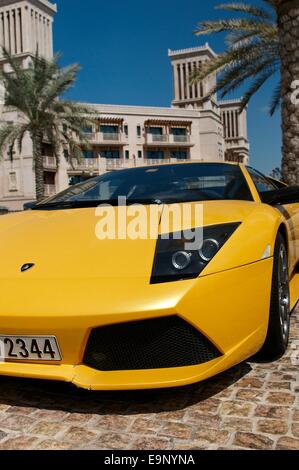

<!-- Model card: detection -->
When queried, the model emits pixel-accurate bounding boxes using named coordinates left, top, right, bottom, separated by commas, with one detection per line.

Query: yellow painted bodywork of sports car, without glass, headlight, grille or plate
left=0, top=166, right=299, bottom=390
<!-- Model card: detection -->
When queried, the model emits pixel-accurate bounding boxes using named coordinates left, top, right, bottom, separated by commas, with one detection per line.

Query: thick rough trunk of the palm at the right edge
left=278, top=0, right=299, bottom=184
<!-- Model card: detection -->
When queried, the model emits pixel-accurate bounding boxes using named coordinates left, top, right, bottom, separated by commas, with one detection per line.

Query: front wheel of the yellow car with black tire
left=258, top=233, right=290, bottom=361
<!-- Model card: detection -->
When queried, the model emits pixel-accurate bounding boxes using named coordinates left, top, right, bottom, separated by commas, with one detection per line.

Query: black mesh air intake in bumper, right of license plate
left=84, top=316, right=221, bottom=371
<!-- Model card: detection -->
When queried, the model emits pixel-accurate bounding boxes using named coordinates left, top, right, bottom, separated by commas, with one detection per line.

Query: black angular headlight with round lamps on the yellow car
left=151, top=222, right=240, bottom=284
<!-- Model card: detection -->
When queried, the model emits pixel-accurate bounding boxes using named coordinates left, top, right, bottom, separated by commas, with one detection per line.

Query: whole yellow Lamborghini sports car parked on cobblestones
left=0, top=162, right=299, bottom=390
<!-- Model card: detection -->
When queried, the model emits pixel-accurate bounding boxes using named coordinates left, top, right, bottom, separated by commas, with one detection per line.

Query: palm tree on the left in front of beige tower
left=0, top=50, right=92, bottom=201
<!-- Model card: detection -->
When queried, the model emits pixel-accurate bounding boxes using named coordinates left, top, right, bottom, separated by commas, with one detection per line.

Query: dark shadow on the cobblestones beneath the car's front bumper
left=0, top=362, right=251, bottom=415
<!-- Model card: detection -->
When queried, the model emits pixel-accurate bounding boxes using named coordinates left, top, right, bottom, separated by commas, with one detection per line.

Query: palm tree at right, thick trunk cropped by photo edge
left=192, top=0, right=299, bottom=184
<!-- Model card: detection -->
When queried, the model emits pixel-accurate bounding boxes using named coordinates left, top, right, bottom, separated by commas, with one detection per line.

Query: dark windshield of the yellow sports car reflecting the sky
left=35, top=163, right=252, bottom=209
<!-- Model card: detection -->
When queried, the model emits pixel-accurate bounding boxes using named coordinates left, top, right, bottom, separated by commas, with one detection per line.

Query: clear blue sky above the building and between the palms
left=53, top=0, right=281, bottom=172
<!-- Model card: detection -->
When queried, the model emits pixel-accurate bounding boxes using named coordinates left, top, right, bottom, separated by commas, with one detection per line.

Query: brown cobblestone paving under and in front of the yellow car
left=0, top=312, right=299, bottom=449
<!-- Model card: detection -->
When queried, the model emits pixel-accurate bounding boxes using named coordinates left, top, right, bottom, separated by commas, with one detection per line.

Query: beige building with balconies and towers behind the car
left=0, top=0, right=249, bottom=210
